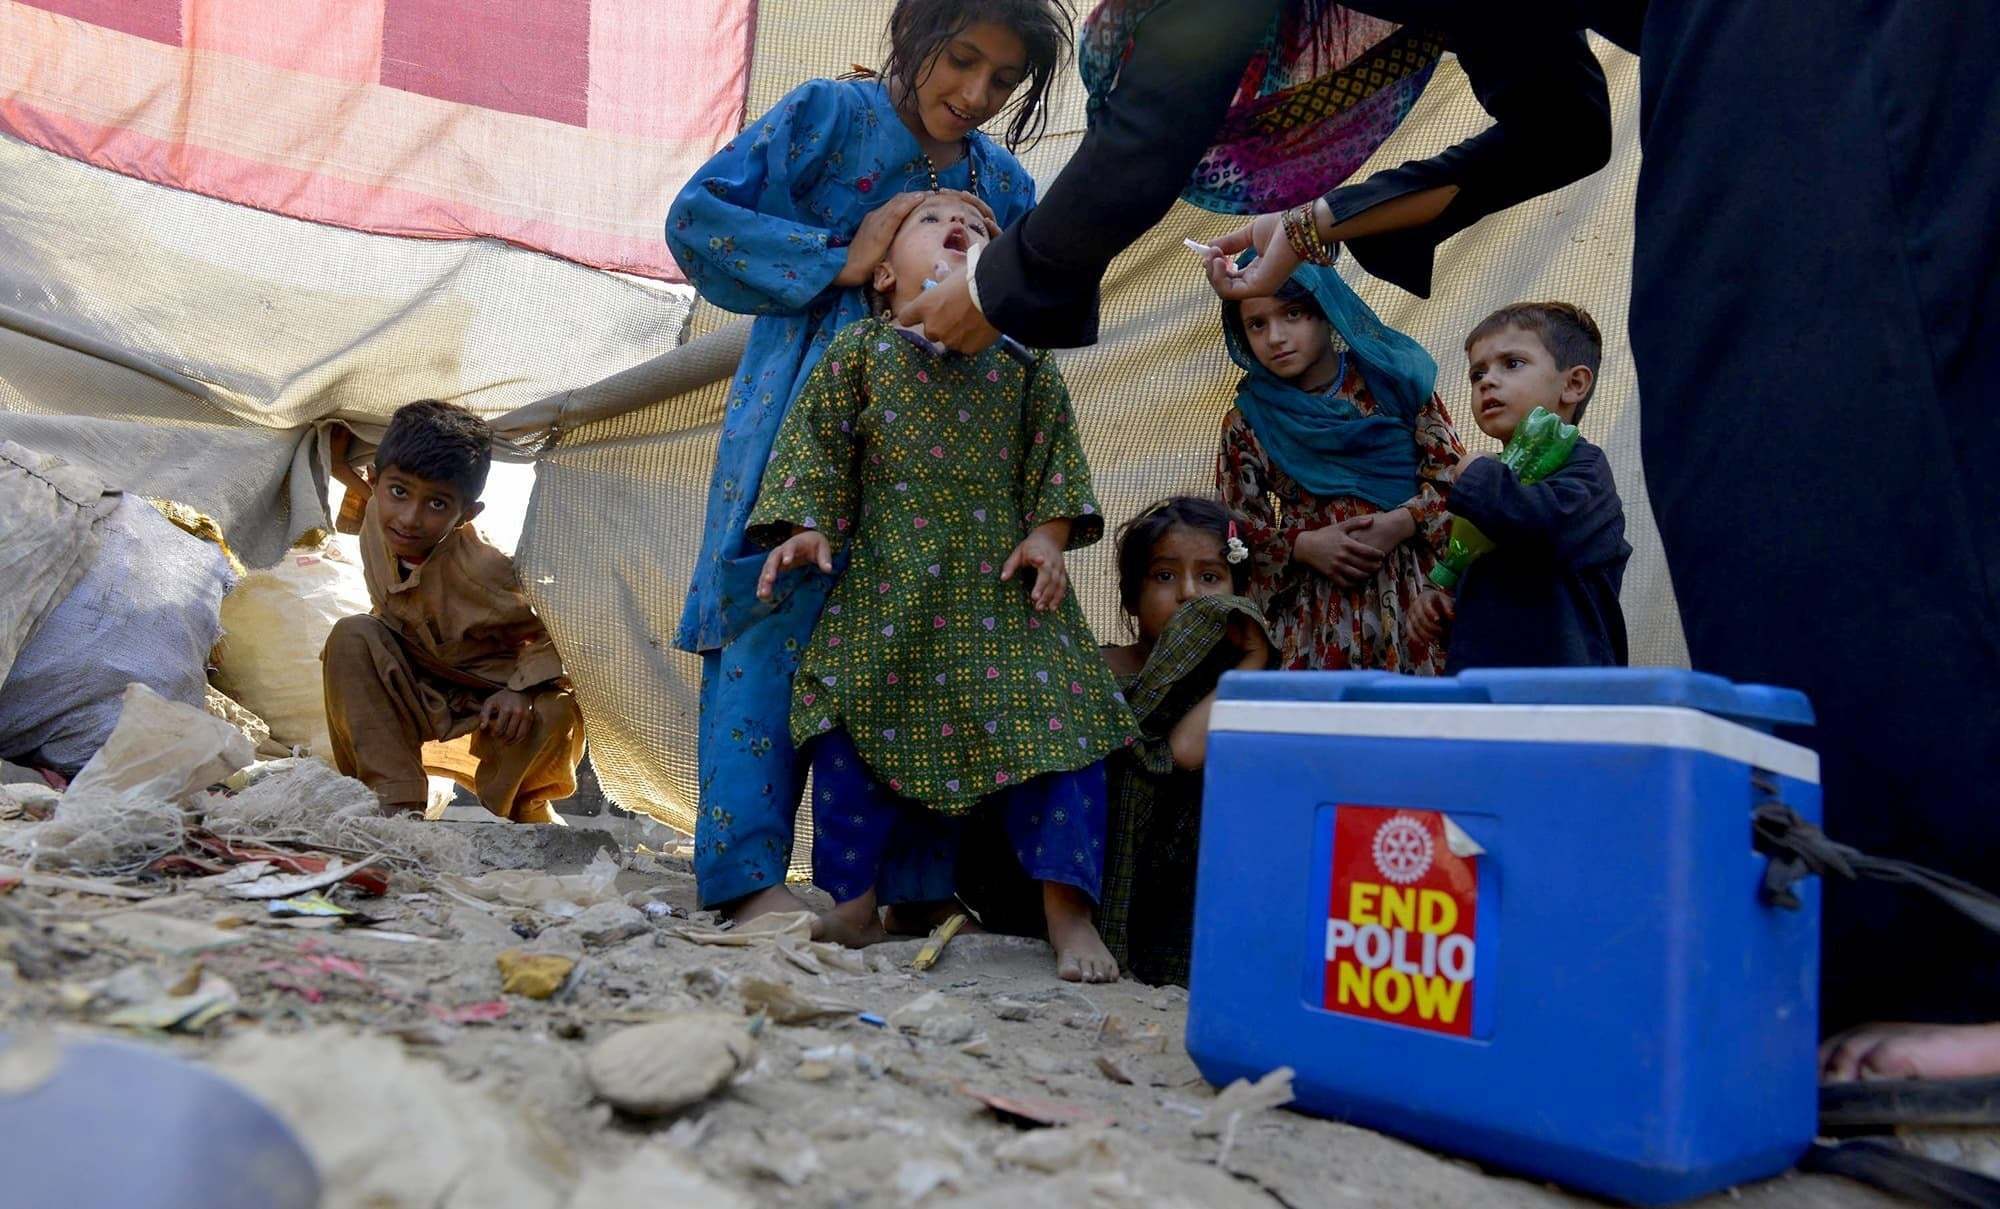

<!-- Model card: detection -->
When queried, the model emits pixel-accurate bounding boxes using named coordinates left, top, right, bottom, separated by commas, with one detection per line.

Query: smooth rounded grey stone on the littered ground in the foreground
left=584, top=1013, right=754, bottom=1117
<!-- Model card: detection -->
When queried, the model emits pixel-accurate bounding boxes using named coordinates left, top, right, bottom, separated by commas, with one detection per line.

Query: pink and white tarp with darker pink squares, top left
left=0, top=0, right=756, bottom=280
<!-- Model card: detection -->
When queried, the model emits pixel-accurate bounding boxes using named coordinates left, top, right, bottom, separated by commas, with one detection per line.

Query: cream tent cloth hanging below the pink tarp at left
left=0, top=136, right=692, bottom=566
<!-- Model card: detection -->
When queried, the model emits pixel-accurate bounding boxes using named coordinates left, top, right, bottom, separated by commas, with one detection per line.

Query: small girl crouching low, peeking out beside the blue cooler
left=1098, top=496, right=1272, bottom=987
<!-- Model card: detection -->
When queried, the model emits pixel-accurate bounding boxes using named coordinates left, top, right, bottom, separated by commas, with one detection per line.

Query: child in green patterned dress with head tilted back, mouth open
left=750, top=194, right=1134, bottom=981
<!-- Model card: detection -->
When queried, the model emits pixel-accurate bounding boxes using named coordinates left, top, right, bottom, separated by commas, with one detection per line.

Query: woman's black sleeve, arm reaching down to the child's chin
left=978, top=0, right=1284, bottom=348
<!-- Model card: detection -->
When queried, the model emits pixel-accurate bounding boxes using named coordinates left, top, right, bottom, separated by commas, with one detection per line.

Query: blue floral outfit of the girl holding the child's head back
left=666, top=80, right=1034, bottom=905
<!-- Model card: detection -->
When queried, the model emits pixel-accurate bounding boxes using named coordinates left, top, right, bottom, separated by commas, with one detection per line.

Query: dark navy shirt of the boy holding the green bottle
left=1444, top=440, right=1632, bottom=677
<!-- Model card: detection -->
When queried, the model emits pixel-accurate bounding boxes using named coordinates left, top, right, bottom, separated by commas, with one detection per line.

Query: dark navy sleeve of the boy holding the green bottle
left=1448, top=440, right=1626, bottom=566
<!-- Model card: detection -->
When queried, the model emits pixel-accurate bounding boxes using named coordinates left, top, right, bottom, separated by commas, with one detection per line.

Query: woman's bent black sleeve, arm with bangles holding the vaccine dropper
left=1320, top=14, right=1612, bottom=298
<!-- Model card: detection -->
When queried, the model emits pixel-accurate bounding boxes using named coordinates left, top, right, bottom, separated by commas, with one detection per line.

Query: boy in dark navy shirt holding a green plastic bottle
left=1410, top=302, right=1632, bottom=675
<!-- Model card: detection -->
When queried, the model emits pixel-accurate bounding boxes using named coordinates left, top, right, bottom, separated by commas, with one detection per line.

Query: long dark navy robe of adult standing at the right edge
left=1624, top=0, right=2000, bottom=1031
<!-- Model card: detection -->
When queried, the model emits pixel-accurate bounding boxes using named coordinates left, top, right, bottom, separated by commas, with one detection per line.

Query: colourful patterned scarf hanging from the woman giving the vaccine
left=1078, top=0, right=1444, bottom=214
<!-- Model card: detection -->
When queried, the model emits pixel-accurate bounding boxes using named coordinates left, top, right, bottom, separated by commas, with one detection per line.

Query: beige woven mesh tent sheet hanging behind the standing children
left=520, top=0, right=1686, bottom=851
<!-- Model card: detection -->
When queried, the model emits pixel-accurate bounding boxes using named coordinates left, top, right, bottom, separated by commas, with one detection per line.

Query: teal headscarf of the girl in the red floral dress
left=1222, top=264, right=1438, bottom=508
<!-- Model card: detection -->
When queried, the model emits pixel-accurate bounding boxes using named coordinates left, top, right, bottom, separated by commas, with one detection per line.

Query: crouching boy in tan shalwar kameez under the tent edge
left=320, top=400, right=584, bottom=823
